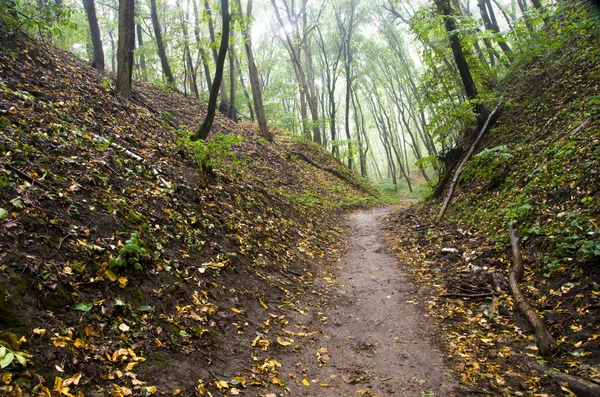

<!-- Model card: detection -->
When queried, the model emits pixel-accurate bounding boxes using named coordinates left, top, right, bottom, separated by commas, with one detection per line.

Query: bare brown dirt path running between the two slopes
left=264, top=207, right=456, bottom=397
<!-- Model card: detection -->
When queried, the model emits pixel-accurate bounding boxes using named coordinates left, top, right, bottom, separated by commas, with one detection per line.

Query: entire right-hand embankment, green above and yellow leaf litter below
left=388, top=3, right=600, bottom=395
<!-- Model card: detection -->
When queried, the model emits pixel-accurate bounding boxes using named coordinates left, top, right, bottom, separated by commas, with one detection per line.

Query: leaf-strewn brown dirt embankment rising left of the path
left=0, top=32, right=373, bottom=396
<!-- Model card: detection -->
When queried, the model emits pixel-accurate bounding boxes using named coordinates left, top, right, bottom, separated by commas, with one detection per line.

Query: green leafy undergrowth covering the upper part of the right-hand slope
left=450, top=4, right=600, bottom=277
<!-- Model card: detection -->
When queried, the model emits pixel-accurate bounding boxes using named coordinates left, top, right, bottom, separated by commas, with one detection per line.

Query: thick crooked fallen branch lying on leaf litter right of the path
left=508, top=225, right=556, bottom=356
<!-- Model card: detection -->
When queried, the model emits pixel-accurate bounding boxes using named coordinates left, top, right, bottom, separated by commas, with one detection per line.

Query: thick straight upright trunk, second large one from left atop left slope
left=117, top=0, right=135, bottom=99
